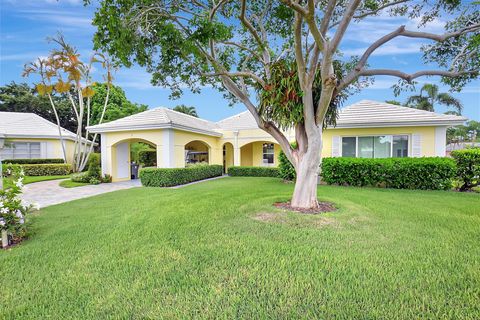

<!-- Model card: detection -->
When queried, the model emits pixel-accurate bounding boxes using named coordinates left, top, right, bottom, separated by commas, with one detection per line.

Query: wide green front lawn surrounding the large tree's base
left=0, top=177, right=480, bottom=319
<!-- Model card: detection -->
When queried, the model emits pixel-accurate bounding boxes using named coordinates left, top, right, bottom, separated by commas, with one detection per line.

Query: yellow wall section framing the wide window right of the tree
left=322, top=127, right=436, bottom=157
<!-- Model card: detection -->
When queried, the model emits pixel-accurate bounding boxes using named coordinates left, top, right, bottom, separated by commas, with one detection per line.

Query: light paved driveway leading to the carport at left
left=22, top=180, right=141, bottom=208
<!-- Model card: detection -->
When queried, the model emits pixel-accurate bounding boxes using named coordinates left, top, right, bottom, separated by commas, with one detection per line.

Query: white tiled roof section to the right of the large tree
left=336, top=100, right=467, bottom=128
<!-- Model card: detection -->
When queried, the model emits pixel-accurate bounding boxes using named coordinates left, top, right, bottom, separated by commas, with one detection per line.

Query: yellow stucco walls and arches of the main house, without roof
left=97, top=126, right=443, bottom=181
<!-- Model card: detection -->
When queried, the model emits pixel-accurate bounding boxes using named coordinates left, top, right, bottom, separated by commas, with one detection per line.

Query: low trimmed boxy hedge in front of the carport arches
left=140, top=165, right=223, bottom=187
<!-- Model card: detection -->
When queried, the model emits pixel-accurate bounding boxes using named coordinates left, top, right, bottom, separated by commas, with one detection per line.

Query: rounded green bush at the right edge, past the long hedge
left=452, top=148, right=480, bottom=191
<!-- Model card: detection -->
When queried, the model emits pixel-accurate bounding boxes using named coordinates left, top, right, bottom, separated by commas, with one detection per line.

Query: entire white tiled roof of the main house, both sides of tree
left=89, top=100, right=467, bottom=136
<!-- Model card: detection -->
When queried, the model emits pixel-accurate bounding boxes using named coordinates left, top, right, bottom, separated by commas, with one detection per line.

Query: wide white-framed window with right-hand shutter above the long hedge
left=342, top=135, right=408, bottom=158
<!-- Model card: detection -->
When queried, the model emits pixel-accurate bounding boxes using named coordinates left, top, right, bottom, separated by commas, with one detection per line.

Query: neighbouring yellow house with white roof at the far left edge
left=0, top=112, right=79, bottom=163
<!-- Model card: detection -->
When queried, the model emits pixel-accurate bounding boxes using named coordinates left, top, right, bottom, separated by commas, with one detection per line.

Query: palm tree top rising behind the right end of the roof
left=406, top=83, right=463, bottom=115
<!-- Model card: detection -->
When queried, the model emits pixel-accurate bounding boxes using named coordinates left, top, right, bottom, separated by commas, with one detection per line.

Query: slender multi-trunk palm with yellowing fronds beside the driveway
left=23, top=35, right=112, bottom=172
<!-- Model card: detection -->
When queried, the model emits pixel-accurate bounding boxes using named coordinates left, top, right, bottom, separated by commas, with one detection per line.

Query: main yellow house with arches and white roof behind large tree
left=89, top=100, right=466, bottom=181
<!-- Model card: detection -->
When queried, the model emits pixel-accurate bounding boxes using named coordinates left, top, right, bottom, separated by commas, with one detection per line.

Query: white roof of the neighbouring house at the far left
left=0, top=112, right=76, bottom=140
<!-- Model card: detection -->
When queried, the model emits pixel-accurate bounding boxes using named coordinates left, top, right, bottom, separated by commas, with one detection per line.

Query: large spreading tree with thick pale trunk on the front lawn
left=86, top=0, right=480, bottom=208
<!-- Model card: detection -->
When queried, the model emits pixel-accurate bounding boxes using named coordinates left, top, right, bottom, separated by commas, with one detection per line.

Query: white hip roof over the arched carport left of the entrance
left=89, top=108, right=221, bottom=136
